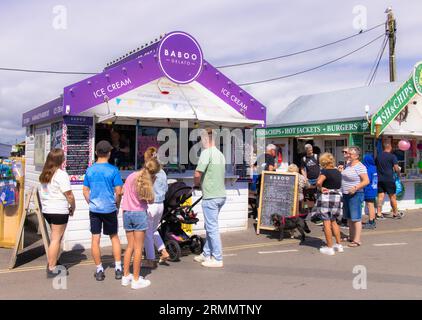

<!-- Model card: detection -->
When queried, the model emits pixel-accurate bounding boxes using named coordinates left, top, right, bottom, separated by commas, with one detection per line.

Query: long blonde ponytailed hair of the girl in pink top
left=136, top=158, right=161, bottom=202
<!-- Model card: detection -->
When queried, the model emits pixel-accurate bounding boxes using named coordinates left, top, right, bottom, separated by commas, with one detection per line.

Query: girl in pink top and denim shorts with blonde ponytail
left=122, top=160, right=161, bottom=289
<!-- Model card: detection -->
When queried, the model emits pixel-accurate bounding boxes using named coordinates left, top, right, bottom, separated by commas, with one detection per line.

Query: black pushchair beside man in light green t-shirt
left=158, top=182, right=205, bottom=261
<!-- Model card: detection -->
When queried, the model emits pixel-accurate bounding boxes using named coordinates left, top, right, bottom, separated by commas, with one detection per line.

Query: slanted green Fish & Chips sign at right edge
left=371, top=63, right=422, bottom=134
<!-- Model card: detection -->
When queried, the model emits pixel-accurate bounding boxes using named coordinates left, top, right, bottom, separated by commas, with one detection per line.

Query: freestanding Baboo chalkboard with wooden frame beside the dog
left=257, top=171, right=298, bottom=234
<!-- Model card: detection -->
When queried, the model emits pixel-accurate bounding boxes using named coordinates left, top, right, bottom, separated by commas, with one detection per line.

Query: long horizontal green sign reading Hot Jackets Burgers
left=256, top=120, right=369, bottom=138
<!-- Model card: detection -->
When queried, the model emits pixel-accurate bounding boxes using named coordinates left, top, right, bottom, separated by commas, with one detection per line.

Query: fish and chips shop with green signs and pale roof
left=256, top=63, right=422, bottom=211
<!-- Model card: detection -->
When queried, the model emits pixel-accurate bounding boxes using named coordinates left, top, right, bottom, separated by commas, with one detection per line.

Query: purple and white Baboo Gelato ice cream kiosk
left=22, top=32, right=266, bottom=250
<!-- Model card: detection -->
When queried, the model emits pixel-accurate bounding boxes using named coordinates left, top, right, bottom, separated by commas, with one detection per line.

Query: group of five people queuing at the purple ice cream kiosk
left=39, top=129, right=226, bottom=289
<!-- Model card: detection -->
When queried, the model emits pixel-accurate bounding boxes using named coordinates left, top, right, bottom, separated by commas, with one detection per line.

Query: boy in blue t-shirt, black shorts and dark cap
left=83, top=140, right=123, bottom=281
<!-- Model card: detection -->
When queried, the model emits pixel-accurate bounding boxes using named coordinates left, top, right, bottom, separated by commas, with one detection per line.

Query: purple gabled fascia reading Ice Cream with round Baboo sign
left=23, top=32, right=266, bottom=126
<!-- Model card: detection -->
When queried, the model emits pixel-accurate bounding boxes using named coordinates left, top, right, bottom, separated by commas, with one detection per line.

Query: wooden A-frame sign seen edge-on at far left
left=9, top=188, right=50, bottom=269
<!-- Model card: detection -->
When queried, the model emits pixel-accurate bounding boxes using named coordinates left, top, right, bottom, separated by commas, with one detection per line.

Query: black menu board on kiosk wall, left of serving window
left=65, top=117, right=92, bottom=184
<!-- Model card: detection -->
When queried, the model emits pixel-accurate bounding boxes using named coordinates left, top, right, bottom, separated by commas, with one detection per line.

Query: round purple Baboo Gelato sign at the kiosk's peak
left=158, top=31, right=203, bottom=84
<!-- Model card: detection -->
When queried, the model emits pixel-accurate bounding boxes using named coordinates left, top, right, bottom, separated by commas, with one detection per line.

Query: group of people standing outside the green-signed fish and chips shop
left=258, top=143, right=403, bottom=255
